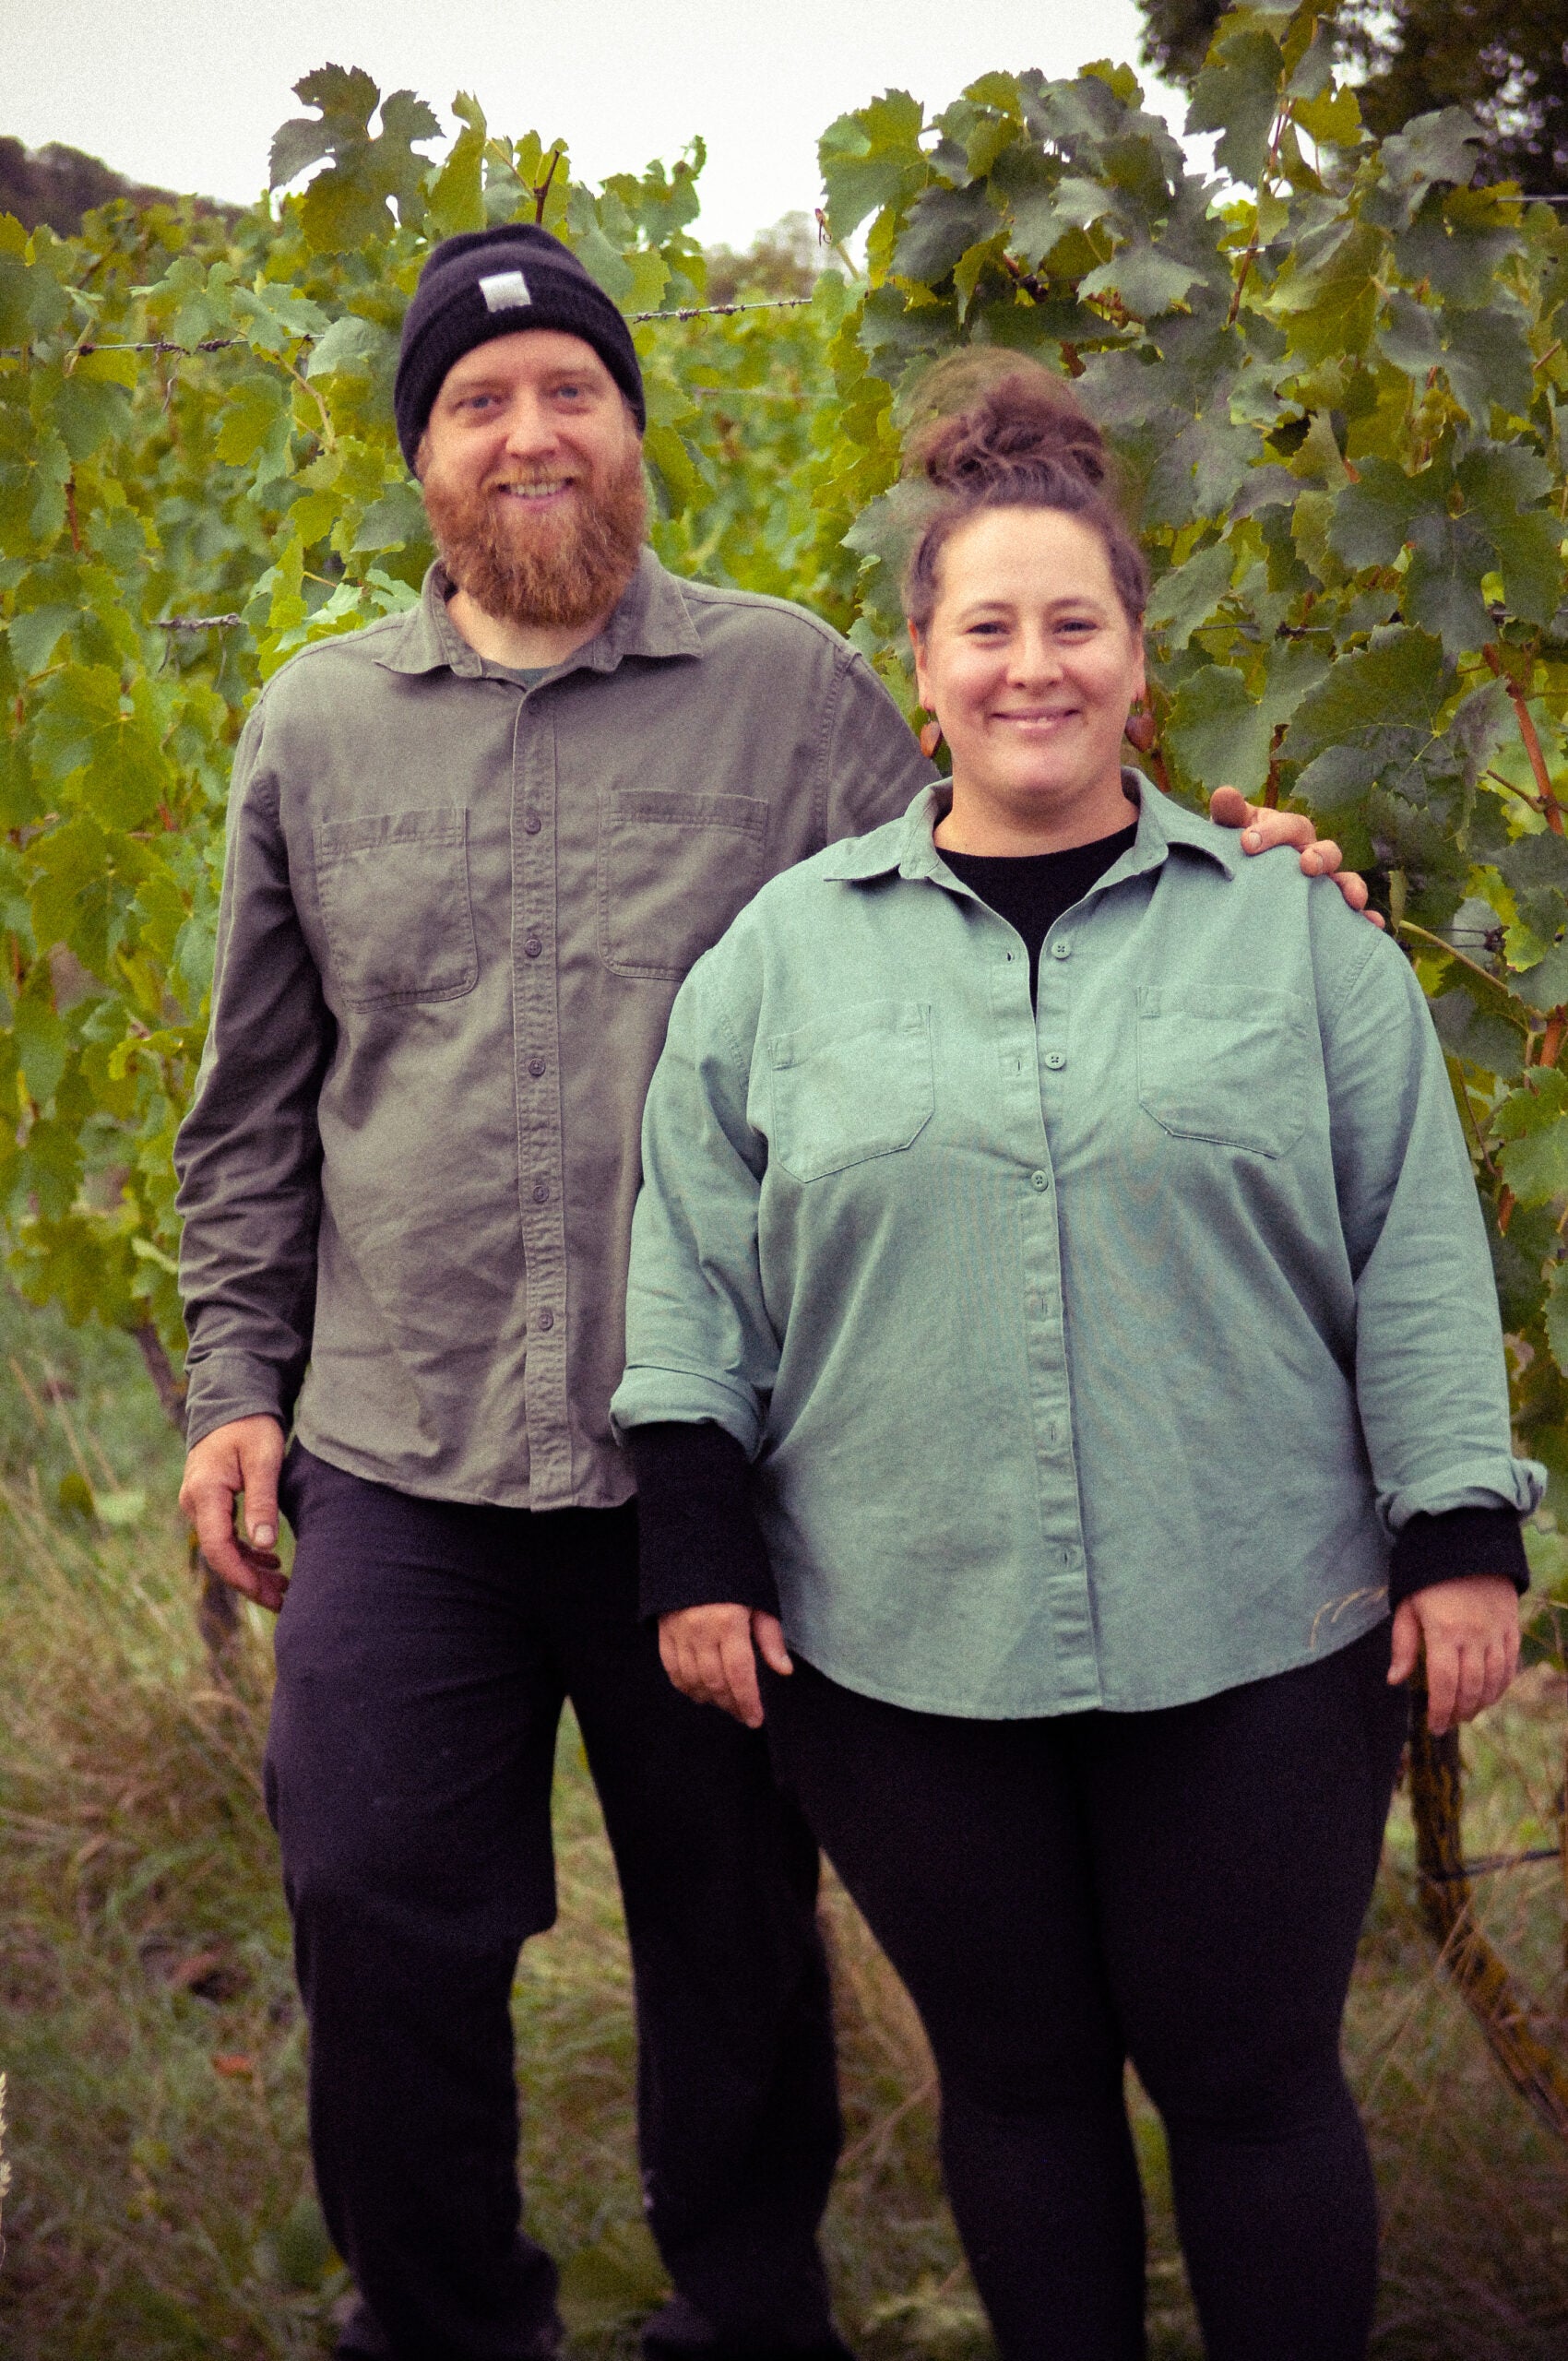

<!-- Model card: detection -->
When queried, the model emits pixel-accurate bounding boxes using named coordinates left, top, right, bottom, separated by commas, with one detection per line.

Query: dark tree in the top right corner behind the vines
left=1143, top=0, right=1568, bottom=196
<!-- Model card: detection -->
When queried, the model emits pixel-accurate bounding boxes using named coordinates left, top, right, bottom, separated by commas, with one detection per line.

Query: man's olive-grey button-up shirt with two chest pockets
left=177, top=552, right=931, bottom=1509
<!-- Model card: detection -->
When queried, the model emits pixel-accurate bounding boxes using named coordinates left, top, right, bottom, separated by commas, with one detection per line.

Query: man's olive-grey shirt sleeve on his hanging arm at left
left=174, top=689, right=336, bottom=1442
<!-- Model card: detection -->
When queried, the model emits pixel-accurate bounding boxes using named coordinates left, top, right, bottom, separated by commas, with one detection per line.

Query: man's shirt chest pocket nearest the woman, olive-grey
left=600, top=786, right=767, bottom=978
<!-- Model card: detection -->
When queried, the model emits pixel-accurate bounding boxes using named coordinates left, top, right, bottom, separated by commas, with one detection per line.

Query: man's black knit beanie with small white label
left=392, top=222, right=647, bottom=468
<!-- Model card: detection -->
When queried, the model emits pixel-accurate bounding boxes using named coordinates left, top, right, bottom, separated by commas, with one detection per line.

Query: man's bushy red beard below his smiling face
left=421, top=448, right=647, bottom=631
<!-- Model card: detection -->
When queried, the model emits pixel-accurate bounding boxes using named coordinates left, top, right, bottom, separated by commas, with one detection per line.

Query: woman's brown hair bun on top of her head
left=905, top=345, right=1110, bottom=496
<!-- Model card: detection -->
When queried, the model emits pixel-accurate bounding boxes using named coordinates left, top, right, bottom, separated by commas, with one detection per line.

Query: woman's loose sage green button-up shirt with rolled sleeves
left=612, top=775, right=1542, bottom=1719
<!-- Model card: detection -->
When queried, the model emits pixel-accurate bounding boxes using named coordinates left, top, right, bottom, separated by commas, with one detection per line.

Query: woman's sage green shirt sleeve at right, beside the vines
left=1323, top=914, right=1544, bottom=1548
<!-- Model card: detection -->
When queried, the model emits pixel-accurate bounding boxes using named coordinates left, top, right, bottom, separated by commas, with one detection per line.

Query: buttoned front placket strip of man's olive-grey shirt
left=513, top=696, right=572, bottom=1509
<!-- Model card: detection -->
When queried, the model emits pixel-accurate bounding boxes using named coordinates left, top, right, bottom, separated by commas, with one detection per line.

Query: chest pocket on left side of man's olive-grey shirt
left=316, top=802, right=480, bottom=1008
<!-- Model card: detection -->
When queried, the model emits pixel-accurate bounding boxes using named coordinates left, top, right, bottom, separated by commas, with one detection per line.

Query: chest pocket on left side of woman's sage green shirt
left=767, top=1001, right=935, bottom=1180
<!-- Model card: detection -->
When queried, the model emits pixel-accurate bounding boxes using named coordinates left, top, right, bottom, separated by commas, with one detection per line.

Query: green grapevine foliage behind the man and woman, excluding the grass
left=0, top=7, right=1568, bottom=1567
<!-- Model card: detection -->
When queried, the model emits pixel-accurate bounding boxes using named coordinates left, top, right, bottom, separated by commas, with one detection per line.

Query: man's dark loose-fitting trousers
left=267, top=1445, right=840, bottom=2361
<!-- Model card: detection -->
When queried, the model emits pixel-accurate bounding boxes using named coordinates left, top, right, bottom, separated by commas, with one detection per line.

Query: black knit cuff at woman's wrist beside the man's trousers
left=625, top=1421, right=779, bottom=1619
